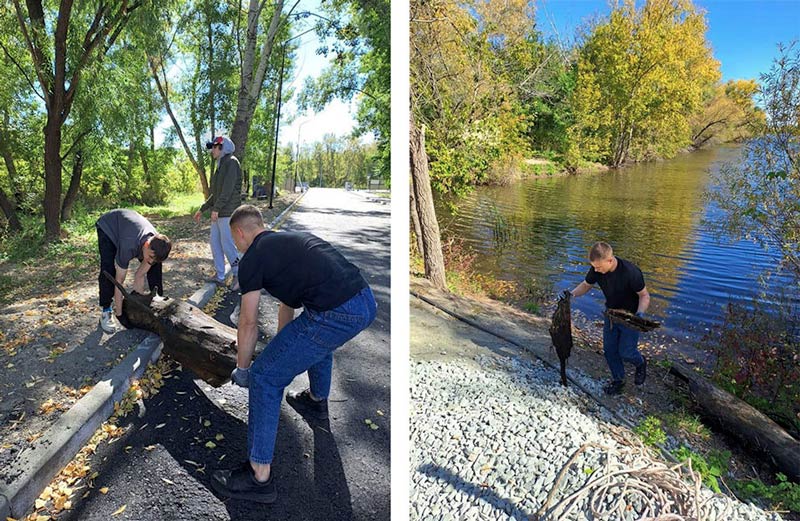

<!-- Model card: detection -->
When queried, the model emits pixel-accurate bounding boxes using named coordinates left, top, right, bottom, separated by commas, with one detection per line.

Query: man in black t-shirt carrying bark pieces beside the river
left=572, top=242, right=650, bottom=394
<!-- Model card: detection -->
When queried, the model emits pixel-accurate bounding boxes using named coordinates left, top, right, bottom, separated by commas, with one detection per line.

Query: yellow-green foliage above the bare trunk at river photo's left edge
left=410, top=0, right=535, bottom=193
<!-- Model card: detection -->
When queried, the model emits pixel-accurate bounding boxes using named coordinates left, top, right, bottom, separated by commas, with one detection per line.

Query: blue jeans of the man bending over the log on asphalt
left=247, top=287, right=377, bottom=464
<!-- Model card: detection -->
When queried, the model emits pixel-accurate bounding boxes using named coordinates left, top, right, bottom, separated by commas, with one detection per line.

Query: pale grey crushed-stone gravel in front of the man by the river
left=410, top=356, right=780, bottom=521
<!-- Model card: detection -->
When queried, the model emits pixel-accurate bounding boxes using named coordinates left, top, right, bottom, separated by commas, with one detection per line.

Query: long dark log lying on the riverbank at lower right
left=670, top=362, right=800, bottom=482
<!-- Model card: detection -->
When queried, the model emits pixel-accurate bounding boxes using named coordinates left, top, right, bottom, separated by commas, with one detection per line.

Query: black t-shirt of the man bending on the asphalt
left=239, top=231, right=367, bottom=311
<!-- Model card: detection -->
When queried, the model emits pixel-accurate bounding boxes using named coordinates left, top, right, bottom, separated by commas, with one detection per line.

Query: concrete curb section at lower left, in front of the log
left=0, top=333, right=162, bottom=519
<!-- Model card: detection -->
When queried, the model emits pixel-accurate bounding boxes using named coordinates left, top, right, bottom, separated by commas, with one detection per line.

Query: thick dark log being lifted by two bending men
left=103, top=272, right=236, bottom=387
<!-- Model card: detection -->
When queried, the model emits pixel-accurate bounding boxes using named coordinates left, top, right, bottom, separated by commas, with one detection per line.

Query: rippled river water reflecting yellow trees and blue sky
left=437, top=147, right=789, bottom=338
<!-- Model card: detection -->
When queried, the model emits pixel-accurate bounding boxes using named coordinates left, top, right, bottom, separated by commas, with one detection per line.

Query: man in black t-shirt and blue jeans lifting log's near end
left=212, top=201, right=377, bottom=503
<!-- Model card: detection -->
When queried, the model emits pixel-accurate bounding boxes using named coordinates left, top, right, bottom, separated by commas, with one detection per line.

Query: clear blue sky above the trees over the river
left=536, top=0, right=800, bottom=81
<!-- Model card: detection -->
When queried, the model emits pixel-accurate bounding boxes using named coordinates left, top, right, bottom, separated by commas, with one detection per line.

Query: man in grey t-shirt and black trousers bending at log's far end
left=95, top=209, right=172, bottom=333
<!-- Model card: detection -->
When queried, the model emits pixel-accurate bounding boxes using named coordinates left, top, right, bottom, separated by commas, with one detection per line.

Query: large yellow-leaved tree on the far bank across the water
left=570, top=0, right=720, bottom=167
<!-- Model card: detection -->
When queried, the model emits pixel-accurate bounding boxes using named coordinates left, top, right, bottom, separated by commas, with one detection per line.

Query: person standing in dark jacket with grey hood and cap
left=194, top=136, right=242, bottom=291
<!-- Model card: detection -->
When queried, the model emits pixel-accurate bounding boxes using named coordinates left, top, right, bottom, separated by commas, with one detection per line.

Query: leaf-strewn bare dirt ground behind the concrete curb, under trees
left=0, top=194, right=299, bottom=474
